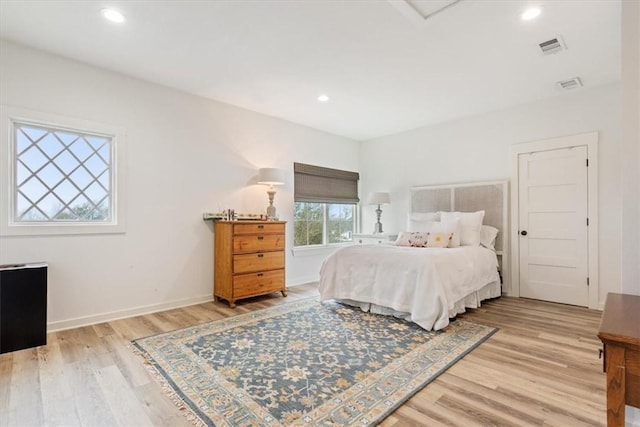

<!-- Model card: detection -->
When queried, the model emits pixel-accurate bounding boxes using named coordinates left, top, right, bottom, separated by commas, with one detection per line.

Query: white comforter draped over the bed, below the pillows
left=320, top=245, right=499, bottom=330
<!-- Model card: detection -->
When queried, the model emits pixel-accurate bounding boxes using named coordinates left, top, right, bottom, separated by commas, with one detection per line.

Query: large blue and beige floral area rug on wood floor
left=133, top=299, right=496, bottom=427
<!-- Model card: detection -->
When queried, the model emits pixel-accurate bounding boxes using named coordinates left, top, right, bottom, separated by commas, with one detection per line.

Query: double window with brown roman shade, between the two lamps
left=294, top=163, right=359, bottom=247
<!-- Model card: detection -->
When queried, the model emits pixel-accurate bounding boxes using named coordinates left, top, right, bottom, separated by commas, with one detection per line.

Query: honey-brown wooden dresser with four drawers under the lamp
left=213, top=221, right=287, bottom=308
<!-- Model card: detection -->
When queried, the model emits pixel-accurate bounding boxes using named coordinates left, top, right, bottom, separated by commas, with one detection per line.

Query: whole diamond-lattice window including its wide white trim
left=1, top=107, right=124, bottom=235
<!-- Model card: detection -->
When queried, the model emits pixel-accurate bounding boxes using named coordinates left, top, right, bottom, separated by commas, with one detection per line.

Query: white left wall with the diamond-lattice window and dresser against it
left=0, top=42, right=360, bottom=329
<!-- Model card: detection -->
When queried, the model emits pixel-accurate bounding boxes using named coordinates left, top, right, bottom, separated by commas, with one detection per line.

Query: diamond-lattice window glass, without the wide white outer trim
left=12, top=121, right=114, bottom=223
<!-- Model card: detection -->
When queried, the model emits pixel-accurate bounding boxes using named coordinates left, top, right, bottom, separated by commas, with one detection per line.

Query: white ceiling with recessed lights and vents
left=0, top=0, right=620, bottom=140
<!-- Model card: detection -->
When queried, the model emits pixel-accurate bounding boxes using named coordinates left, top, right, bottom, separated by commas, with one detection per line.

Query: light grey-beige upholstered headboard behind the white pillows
left=410, top=180, right=510, bottom=289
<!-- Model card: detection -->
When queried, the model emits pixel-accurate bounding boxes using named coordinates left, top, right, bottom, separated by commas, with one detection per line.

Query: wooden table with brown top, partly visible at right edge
left=598, top=293, right=640, bottom=427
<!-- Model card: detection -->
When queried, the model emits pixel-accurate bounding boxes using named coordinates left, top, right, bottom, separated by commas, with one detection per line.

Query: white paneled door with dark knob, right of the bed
left=518, top=146, right=589, bottom=306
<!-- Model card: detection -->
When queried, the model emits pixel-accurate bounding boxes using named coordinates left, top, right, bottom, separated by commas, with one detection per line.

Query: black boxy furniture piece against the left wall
left=0, top=264, right=47, bottom=353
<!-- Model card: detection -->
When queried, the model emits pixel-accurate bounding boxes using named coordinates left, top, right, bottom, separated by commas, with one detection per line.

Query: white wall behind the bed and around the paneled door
left=361, top=84, right=621, bottom=302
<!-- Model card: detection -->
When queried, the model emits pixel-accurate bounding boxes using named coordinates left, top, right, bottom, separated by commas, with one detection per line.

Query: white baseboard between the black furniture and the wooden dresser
left=47, top=294, right=213, bottom=332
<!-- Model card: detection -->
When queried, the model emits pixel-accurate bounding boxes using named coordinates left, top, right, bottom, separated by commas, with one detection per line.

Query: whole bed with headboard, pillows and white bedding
left=319, top=181, right=508, bottom=330
